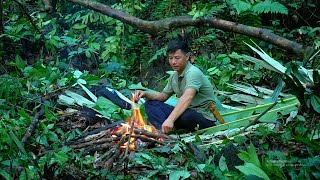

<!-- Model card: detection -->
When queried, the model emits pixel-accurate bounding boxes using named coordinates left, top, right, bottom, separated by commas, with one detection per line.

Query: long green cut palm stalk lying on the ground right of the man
left=195, top=98, right=300, bottom=134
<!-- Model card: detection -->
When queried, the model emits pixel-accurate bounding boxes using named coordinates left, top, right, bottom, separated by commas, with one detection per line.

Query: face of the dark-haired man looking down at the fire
left=169, top=49, right=189, bottom=74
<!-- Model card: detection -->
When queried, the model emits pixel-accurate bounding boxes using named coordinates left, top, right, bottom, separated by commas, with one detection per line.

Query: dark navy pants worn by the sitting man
left=145, top=101, right=215, bottom=131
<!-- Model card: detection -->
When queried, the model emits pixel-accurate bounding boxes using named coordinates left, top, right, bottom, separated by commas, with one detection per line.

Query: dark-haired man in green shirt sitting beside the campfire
left=135, top=39, right=216, bottom=133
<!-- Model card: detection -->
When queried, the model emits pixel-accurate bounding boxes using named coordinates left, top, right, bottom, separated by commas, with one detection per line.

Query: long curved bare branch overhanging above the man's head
left=68, top=0, right=307, bottom=56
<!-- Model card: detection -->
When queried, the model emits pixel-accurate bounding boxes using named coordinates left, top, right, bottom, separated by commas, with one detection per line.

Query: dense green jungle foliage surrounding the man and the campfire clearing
left=0, top=0, right=320, bottom=179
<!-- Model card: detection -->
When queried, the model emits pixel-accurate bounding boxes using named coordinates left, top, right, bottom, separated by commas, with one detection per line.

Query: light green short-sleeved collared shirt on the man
left=162, top=62, right=216, bottom=121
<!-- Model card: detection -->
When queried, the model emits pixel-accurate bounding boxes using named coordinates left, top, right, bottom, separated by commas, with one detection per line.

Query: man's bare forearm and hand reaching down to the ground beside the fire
left=162, top=88, right=197, bottom=133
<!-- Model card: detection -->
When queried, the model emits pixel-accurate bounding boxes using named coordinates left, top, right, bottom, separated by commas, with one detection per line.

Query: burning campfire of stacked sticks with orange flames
left=66, top=95, right=171, bottom=170
